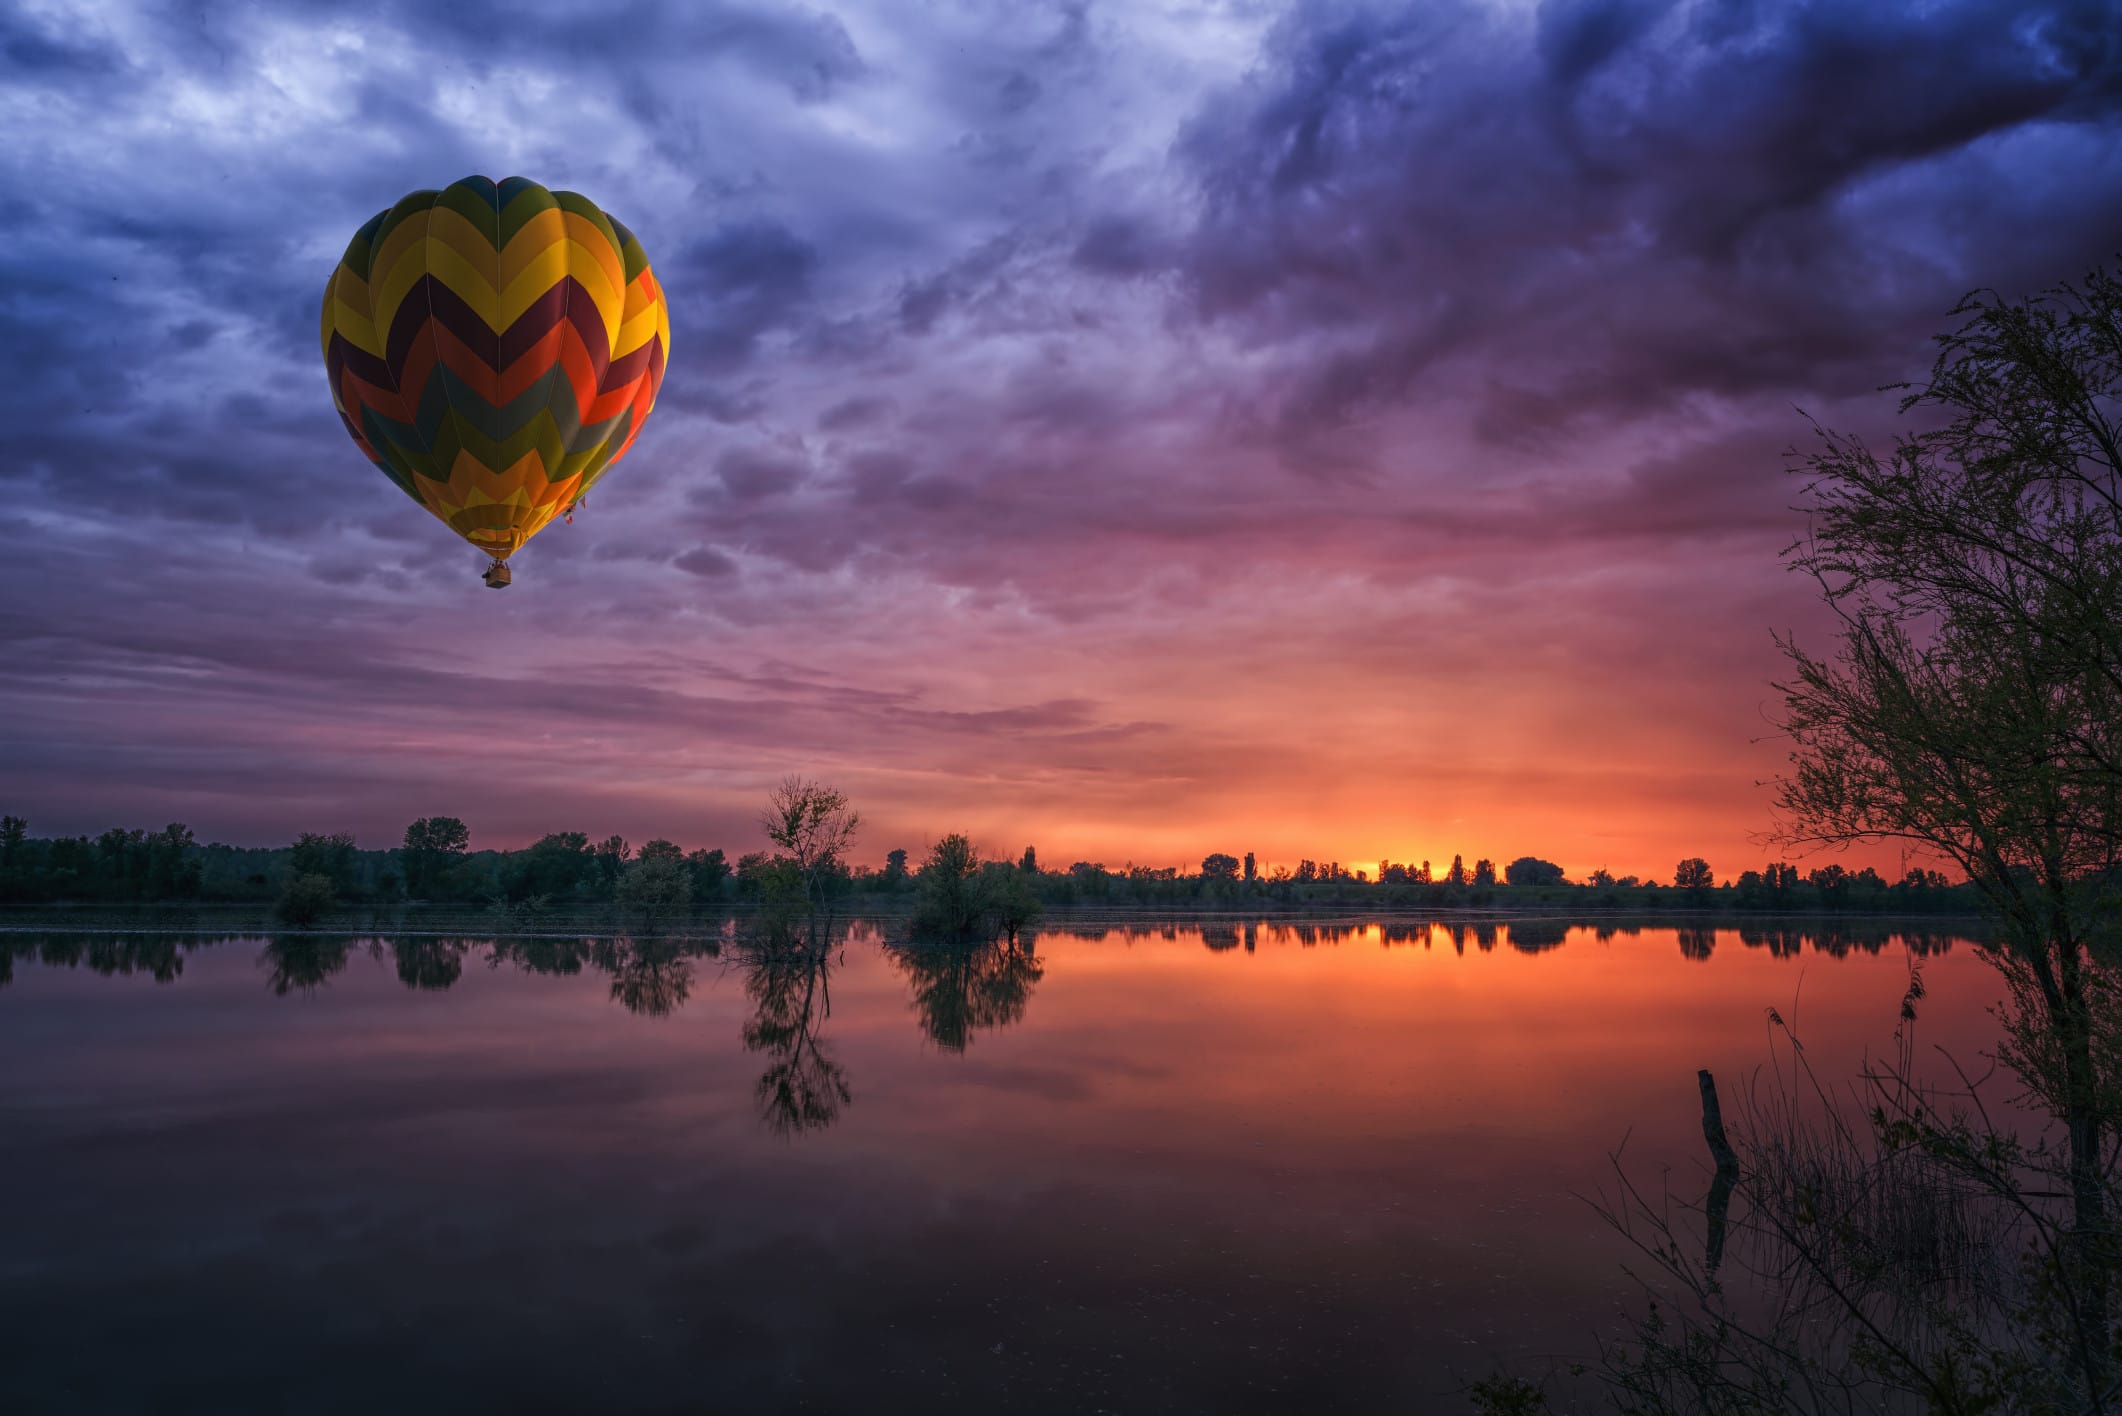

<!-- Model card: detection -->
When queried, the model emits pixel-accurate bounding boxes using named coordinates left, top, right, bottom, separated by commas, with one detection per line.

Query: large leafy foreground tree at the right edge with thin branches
left=1638, top=272, right=2122, bottom=1410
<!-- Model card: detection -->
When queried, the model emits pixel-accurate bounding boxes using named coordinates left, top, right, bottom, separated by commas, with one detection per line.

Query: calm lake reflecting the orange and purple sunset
left=0, top=919, right=1999, bottom=1414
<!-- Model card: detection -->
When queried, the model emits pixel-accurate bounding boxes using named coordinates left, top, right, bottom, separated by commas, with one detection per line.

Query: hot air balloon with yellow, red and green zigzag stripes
left=323, top=176, right=671, bottom=588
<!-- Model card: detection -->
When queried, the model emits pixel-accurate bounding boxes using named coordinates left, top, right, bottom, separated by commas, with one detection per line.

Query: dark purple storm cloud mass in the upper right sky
left=1179, top=0, right=2122, bottom=447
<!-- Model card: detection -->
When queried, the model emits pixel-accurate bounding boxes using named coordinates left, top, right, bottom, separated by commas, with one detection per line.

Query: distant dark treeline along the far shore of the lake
left=0, top=815, right=1980, bottom=915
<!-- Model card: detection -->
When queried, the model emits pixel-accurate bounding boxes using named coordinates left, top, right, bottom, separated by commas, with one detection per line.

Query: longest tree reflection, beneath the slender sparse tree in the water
left=736, top=936, right=853, bottom=1136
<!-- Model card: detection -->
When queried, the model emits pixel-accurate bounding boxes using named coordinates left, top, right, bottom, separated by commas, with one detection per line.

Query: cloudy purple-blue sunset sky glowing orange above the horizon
left=0, top=0, right=2122, bottom=877
